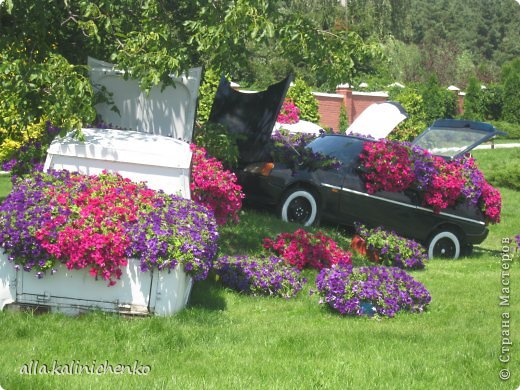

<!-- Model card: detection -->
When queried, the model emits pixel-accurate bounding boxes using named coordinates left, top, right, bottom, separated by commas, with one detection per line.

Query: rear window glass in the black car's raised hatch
left=415, top=128, right=489, bottom=157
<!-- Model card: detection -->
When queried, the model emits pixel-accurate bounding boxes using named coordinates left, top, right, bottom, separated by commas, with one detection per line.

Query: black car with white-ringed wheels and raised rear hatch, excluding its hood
left=237, top=120, right=506, bottom=258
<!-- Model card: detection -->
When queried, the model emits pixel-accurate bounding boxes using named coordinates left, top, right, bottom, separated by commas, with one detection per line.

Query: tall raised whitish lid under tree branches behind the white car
left=88, top=57, right=202, bottom=142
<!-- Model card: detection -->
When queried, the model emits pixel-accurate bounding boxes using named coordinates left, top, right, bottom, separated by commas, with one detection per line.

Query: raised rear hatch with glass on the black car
left=412, top=119, right=506, bottom=159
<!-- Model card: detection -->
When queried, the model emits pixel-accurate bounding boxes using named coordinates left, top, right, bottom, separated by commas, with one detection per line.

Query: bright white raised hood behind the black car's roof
left=345, top=102, right=408, bottom=139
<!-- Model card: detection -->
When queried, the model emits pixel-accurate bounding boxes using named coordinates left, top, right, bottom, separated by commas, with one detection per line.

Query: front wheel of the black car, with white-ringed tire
left=280, top=188, right=319, bottom=226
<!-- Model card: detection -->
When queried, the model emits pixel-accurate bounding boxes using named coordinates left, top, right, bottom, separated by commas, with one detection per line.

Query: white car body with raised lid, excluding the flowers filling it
left=0, top=60, right=201, bottom=316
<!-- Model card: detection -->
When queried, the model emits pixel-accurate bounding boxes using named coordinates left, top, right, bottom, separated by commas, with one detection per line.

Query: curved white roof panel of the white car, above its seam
left=48, top=129, right=191, bottom=168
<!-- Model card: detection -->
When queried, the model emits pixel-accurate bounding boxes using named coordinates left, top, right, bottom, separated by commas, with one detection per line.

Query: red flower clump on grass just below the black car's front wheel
left=264, top=229, right=352, bottom=270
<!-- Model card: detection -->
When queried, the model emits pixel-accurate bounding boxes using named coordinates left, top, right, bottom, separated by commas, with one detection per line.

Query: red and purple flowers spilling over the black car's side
left=360, top=140, right=502, bottom=223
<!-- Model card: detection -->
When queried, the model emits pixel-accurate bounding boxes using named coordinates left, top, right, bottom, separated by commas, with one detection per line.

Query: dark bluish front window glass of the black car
left=307, top=135, right=363, bottom=165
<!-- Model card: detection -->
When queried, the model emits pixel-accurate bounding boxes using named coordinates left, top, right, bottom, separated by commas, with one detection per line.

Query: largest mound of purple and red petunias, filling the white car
left=0, top=171, right=218, bottom=286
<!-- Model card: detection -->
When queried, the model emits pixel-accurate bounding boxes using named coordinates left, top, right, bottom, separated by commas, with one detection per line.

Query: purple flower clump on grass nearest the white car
left=214, top=256, right=306, bottom=298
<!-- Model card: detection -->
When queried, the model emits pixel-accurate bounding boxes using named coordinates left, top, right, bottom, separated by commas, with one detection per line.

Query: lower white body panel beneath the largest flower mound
left=0, top=254, right=193, bottom=316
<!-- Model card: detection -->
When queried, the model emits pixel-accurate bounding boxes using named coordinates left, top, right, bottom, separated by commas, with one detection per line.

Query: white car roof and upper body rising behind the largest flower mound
left=44, top=129, right=192, bottom=199
